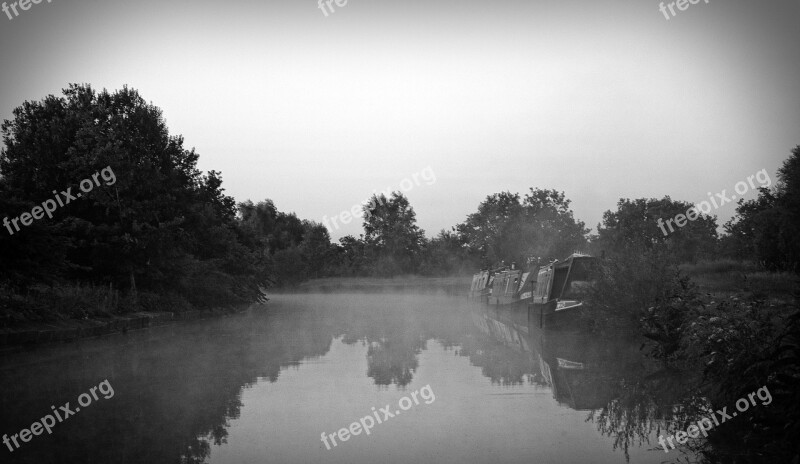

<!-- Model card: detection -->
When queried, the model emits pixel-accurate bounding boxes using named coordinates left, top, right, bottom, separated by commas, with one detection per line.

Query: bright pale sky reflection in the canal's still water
left=205, top=341, right=663, bottom=463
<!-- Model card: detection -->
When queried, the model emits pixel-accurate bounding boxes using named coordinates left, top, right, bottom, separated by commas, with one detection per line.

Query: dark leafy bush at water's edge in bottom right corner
left=677, top=295, right=800, bottom=462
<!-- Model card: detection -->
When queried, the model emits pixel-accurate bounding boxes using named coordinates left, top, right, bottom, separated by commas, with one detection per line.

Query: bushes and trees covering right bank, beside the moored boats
left=584, top=147, right=800, bottom=463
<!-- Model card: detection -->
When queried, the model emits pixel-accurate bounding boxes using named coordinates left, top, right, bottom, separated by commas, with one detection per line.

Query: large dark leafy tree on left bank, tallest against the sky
left=0, top=84, right=264, bottom=304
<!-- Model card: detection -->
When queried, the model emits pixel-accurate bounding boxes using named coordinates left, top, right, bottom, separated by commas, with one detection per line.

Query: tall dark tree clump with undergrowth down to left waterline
left=0, top=85, right=276, bottom=322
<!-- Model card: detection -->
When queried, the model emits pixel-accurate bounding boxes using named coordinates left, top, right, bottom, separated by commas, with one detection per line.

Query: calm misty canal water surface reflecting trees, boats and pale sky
left=0, top=293, right=692, bottom=464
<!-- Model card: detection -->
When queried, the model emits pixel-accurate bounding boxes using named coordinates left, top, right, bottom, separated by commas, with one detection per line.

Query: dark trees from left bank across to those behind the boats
left=0, top=84, right=608, bottom=326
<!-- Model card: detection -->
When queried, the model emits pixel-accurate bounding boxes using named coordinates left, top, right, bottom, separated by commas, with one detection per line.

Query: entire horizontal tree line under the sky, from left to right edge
left=0, top=84, right=800, bottom=320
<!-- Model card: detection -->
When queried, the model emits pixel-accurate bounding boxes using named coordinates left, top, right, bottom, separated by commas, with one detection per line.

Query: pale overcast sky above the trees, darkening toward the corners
left=0, top=0, right=800, bottom=239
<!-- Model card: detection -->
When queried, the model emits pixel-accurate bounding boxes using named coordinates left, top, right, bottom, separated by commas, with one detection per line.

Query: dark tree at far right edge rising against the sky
left=722, top=145, right=800, bottom=272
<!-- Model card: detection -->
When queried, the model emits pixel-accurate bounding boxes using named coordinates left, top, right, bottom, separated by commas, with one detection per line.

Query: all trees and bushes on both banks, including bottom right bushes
left=0, top=85, right=800, bottom=462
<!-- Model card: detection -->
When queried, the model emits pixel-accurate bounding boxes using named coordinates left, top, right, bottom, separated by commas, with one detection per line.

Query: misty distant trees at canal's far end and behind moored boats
left=322, top=189, right=588, bottom=276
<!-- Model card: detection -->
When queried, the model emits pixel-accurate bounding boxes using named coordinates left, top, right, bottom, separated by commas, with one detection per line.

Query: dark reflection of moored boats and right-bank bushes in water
left=464, top=307, right=689, bottom=458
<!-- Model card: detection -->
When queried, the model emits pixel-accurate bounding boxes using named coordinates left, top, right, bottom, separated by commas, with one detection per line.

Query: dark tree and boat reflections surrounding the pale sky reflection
left=0, top=294, right=700, bottom=464
